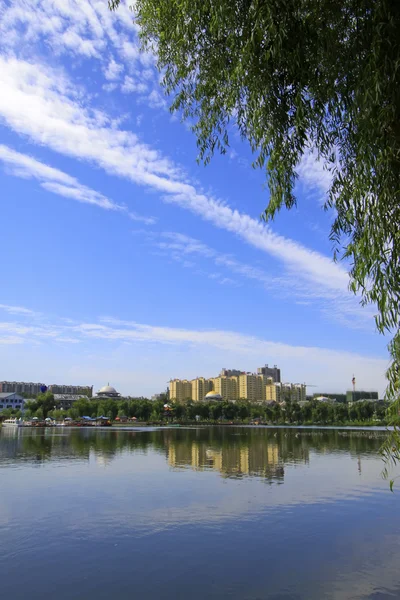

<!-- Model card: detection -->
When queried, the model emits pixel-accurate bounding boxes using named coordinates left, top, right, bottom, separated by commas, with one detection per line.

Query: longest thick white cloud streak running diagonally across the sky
left=0, top=57, right=348, bottom=304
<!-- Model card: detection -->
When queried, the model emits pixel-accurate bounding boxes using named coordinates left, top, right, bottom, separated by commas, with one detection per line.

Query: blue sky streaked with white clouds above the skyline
left=0, top=0, right=389, bottom=396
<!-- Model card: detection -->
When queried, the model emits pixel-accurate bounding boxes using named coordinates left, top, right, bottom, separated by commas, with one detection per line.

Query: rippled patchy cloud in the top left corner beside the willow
left=0, top=0, right=160, bottom=109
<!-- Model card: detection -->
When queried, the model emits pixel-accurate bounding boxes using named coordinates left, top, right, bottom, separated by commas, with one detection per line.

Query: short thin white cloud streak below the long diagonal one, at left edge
left=0, top=144, right=156, bottom=225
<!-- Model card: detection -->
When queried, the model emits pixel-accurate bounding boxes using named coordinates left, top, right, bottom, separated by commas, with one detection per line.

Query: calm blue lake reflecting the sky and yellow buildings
left=0, top=426, right=400, bottom=600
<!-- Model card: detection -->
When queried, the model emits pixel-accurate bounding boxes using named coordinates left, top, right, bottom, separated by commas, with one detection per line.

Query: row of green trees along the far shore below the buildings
left=3, top=393, right=388, bottom=424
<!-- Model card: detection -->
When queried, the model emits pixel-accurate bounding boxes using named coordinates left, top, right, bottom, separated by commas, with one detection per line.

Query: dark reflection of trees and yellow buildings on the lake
left=0, top=427, right=385, bottom=481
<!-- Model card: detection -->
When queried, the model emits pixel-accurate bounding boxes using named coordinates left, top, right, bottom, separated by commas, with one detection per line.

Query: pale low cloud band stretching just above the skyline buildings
left=0, top=309, right=388, bottom=393
